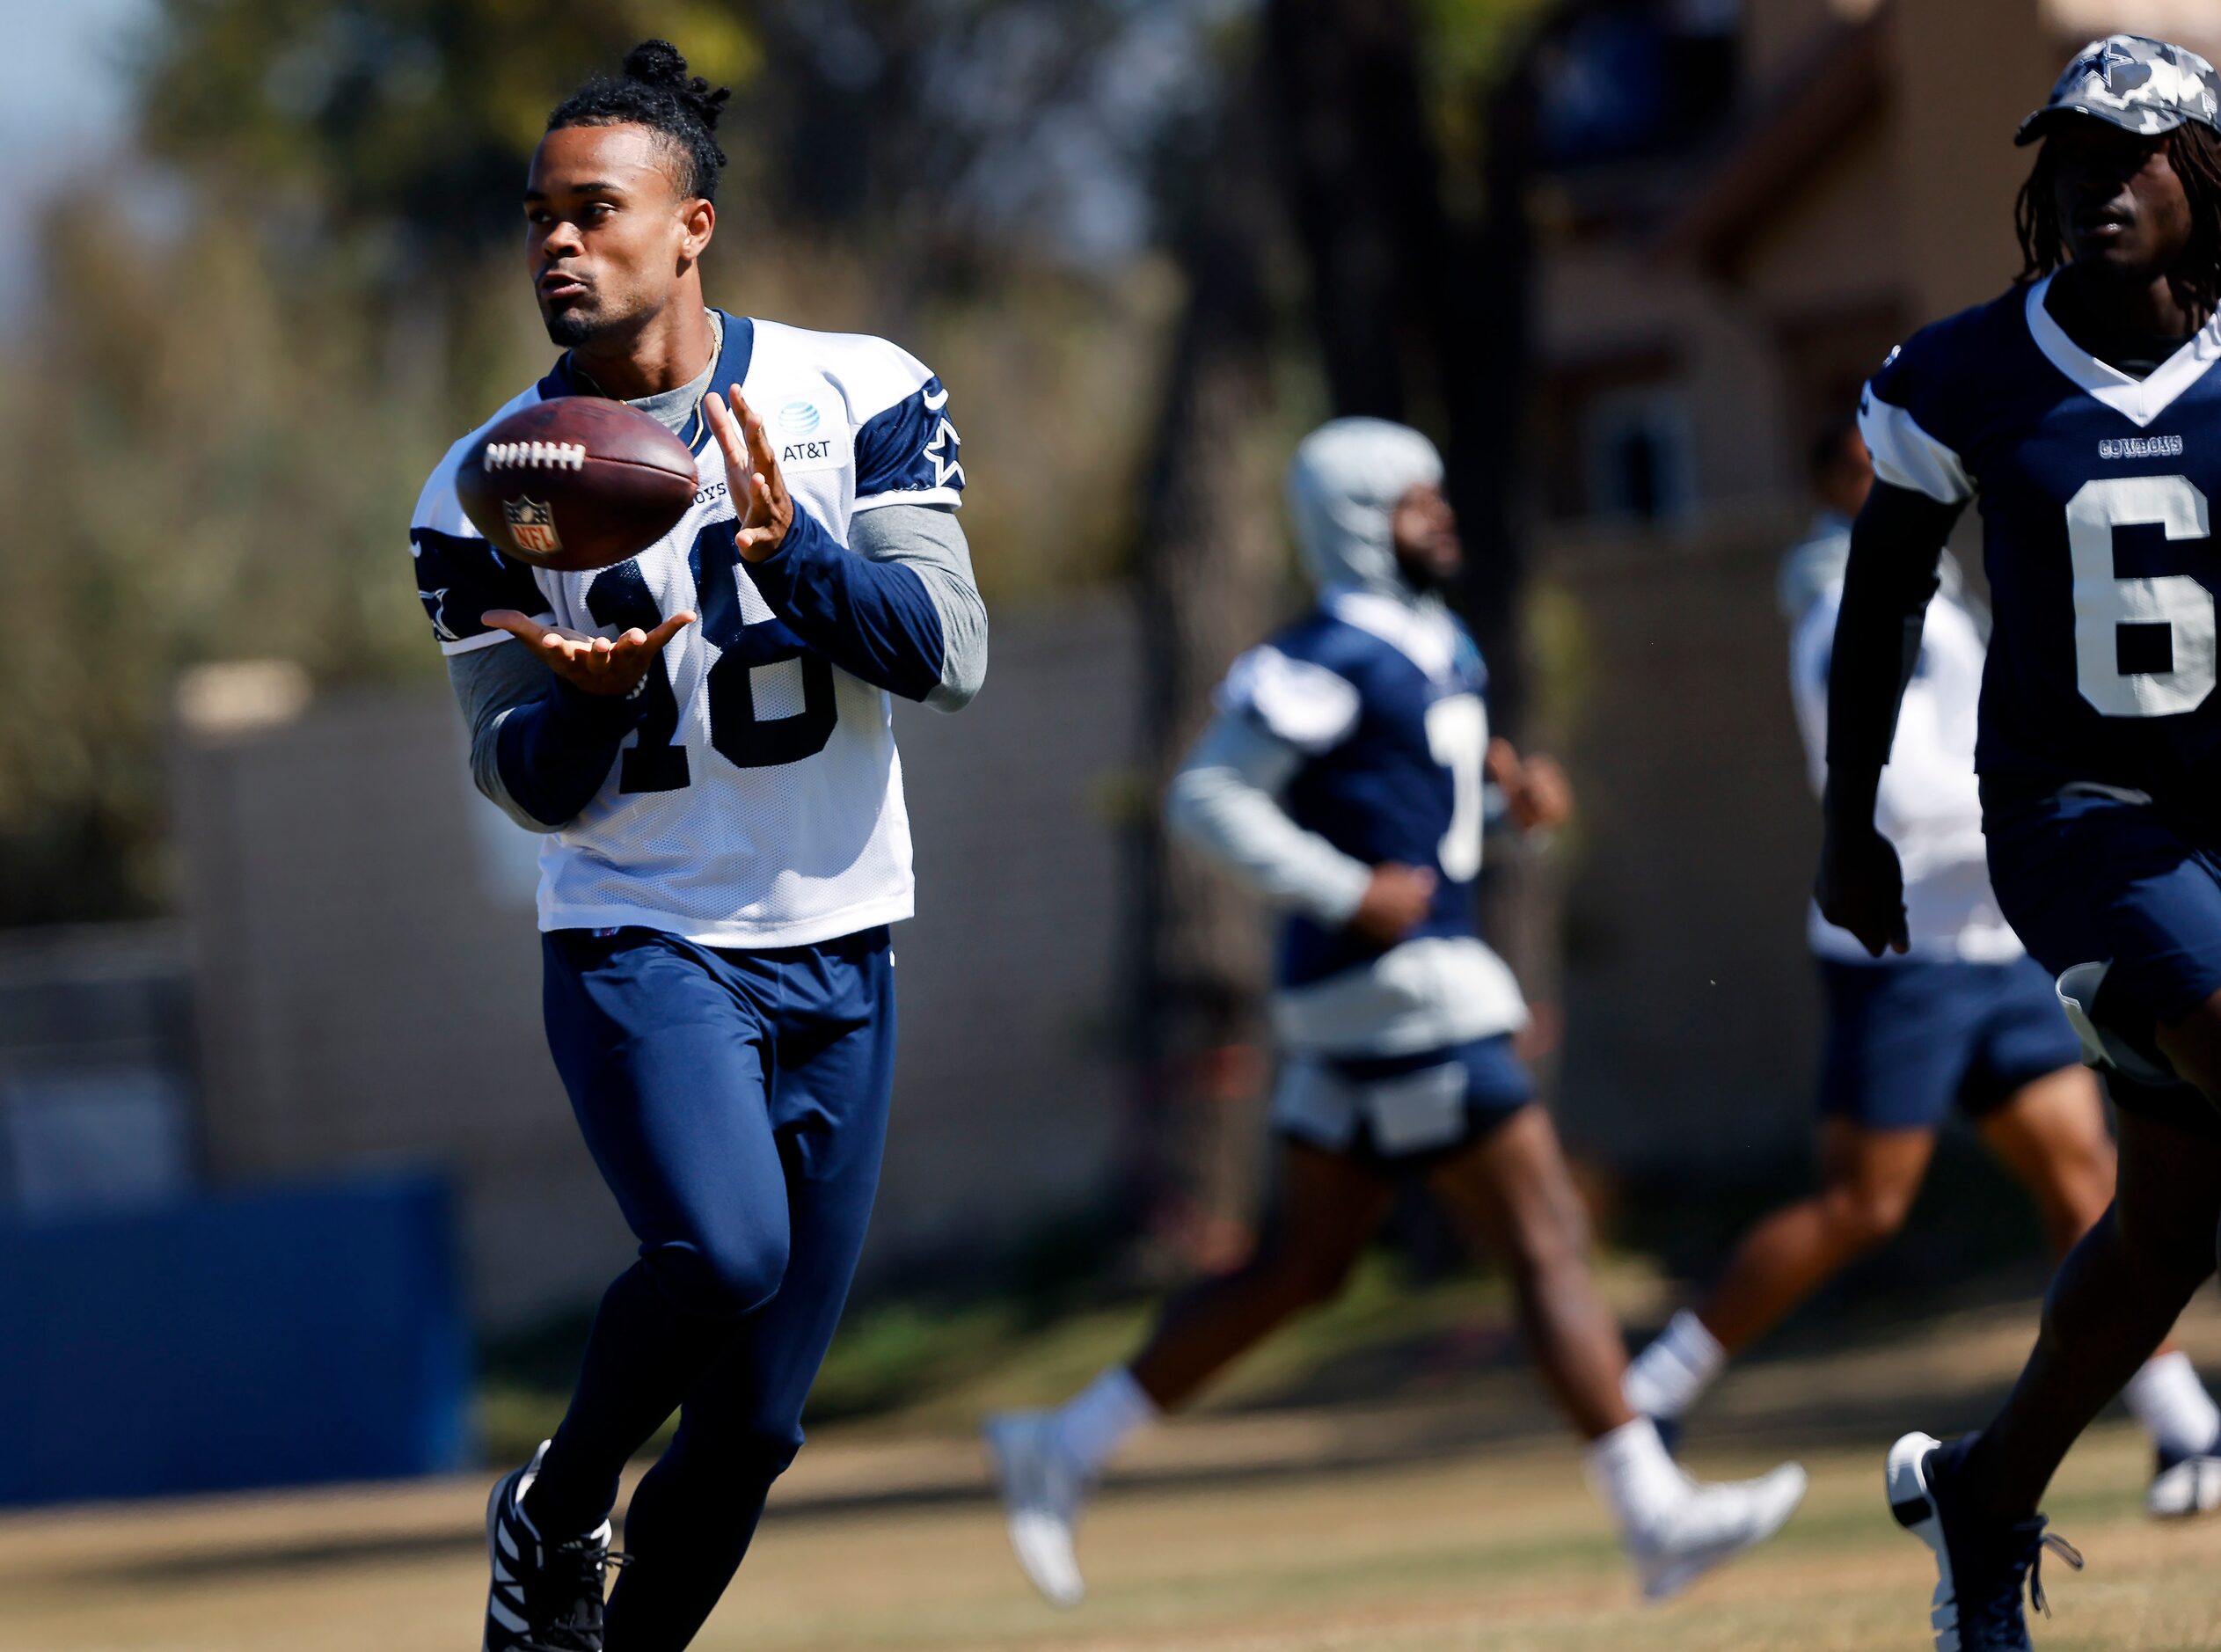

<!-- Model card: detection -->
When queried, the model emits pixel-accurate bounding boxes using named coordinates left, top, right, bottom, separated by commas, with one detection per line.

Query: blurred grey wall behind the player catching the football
left=168, top=602, right=1135, bottom=1327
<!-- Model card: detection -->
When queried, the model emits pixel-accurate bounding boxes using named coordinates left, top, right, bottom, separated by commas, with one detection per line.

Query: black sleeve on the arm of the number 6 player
left=1828, top=482, right=1963, bottom=782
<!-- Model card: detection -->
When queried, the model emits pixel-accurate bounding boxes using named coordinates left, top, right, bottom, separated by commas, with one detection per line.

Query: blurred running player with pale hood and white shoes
left=986, top=420, right=1803, bottom=1605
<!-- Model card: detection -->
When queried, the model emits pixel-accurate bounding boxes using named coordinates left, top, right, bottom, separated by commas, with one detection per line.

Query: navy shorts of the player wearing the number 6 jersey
left=1984, top=795, right=2221, bottom=1139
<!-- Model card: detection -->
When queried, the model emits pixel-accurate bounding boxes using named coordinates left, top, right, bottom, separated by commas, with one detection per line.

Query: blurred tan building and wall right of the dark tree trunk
left=1531, top=0, right=2221, bottom=1170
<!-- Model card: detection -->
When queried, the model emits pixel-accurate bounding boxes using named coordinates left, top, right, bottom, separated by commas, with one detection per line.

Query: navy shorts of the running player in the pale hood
left=1273, top=1033, right=1535, bottom=1166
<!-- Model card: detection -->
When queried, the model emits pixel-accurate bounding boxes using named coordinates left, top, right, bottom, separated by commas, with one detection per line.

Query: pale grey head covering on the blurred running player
left=1289, top=420, right=1442, bottom=600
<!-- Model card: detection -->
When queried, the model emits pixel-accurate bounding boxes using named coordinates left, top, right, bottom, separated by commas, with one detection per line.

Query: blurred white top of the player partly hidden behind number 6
left=1790, top=584, right=2021, bottom=964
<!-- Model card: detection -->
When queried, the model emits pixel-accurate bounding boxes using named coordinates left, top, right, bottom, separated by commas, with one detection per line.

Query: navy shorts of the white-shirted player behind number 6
left=1819, top=957, right=2081, bottom=1130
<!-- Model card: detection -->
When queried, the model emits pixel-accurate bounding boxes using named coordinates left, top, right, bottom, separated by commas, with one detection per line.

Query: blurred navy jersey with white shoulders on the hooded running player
left=1224, top=590, right=1488, bottom=986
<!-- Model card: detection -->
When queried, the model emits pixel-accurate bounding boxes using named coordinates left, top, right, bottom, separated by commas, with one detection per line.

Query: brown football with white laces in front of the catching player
left=456, top=395, right=699, bottom=573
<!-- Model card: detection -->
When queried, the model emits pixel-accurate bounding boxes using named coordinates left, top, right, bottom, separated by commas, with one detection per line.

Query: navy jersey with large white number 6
left=1859, top=280, right=2221, bottom=822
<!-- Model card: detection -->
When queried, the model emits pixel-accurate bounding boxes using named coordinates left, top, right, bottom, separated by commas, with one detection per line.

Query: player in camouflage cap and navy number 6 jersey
left=1819, top=35, right=2221, bottom=1652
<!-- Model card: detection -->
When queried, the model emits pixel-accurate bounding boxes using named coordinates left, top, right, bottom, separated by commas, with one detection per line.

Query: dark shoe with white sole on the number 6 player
left=1888, top=1435, right=2081, bottom=1652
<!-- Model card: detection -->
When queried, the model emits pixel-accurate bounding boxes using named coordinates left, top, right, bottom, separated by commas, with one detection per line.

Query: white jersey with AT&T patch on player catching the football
left=411, top=315, right=964, bottom=948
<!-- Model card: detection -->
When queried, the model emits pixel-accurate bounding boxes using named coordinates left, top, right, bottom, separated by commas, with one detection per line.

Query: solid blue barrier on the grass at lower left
left=0, top=1174, right=471, bottom=1503
